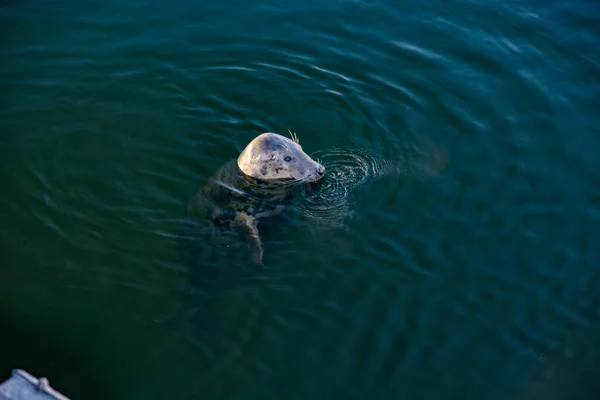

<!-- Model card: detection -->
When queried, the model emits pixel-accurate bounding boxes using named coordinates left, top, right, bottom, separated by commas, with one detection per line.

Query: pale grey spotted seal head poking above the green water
left=237, top=132, right=325, bottom=182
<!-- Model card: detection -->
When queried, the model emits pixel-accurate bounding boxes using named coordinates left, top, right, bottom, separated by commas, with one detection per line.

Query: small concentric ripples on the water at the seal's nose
left=293, top=149, right=392, bottom=227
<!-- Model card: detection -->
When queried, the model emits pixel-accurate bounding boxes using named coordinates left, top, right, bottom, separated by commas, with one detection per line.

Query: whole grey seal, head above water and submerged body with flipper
left=186, top=132, right=325, bottom=265
